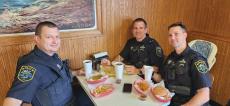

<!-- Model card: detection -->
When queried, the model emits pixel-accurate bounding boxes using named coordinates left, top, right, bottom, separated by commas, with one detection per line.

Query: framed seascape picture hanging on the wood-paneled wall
left=0, top=0, right=97, bottom=36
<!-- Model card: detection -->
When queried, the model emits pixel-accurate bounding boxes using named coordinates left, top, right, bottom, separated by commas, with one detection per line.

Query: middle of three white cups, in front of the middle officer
left=115, top=62, right=124, bottom=80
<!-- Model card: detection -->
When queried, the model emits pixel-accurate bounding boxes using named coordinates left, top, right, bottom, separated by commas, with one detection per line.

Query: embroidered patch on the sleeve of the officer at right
left=195, top=60, right=208, bottom=73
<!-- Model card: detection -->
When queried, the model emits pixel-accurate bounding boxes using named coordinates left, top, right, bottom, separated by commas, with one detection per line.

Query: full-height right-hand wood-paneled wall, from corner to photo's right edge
left=192, top=0, right=230, bottom=105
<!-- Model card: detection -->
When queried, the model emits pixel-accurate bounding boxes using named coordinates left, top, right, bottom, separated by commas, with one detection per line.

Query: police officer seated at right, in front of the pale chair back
left=154, top=22, right=211, bottom=106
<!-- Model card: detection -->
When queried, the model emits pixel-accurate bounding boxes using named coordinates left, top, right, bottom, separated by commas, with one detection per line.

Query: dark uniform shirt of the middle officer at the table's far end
left=120, top=34, right=164, bottom=68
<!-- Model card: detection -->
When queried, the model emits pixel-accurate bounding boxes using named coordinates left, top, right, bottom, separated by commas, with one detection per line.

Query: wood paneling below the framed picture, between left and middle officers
left=59, top=36, right=105, bottom=69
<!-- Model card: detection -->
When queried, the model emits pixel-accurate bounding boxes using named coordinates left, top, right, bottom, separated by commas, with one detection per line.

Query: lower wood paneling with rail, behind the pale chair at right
left=188, top=31, right=230, bottom=105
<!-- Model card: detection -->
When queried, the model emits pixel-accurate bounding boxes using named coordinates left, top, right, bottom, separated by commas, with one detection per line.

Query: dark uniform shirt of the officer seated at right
left=161, top=46, right=211, bottom=96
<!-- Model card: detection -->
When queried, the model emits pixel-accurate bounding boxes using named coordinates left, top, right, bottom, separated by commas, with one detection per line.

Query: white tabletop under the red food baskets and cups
left=77, top=75, right=168, bottom=106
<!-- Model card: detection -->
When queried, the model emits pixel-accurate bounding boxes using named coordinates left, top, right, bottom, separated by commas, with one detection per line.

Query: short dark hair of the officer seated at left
left=35, top=21, right=58, bottom=36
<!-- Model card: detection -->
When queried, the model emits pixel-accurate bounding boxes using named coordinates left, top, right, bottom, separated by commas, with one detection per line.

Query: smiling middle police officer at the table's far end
left=101, top=18, right=164, bottom=74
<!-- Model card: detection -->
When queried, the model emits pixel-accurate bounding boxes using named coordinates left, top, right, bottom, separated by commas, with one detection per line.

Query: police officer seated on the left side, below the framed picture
left=3, top=21, right=74, bottom=106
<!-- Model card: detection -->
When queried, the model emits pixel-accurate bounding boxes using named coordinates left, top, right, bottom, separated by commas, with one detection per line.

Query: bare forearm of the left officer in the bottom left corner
left=3, top=97, right=22, bottom=106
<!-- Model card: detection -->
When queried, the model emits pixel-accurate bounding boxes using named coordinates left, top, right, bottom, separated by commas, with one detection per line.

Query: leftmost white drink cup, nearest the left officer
left=83, top=60, right=93, bottom=78
